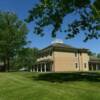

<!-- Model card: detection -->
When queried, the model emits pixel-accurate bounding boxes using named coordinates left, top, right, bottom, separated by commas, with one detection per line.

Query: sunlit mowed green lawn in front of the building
left=0, top=72, right=100, bottom=100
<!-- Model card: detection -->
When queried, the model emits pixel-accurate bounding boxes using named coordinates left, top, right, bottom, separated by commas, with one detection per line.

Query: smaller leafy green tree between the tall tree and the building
left=12, top=48, right=38, bottom=70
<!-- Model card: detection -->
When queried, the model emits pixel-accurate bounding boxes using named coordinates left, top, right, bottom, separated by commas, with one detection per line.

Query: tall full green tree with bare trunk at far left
left=0, top=12, right=28, bottom=71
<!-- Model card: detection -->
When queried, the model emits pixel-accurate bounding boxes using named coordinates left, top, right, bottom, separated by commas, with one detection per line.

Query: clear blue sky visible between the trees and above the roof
left=0, top=0, right=100, bottom=53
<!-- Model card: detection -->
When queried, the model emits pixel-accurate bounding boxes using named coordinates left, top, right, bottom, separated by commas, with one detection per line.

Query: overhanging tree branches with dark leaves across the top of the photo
left=26, top=0, right=100, bottom=41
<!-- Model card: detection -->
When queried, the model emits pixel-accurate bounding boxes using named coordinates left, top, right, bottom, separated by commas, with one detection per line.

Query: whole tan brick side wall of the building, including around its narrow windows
left=54, top=52, right=89, bottom=72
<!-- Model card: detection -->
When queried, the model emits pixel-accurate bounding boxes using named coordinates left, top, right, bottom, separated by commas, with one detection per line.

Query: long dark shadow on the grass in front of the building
left=34, top=72, right=100, bottom=83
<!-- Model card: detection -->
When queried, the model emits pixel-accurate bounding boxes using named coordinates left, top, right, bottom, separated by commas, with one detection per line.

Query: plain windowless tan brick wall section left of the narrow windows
left=54, top=52, right=77, bottom=72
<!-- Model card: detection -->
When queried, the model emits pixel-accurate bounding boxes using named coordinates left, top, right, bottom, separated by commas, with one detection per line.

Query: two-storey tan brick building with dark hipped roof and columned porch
left=33, top=43, right=100, bottom=72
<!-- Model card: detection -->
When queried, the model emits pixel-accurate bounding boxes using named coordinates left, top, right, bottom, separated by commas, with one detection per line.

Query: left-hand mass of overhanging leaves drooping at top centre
left=27, top=0, right=77, bottom=37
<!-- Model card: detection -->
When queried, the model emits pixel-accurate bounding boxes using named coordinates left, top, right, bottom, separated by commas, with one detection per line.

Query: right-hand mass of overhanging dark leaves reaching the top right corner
left=66, top=0, right=100, bottom=42
